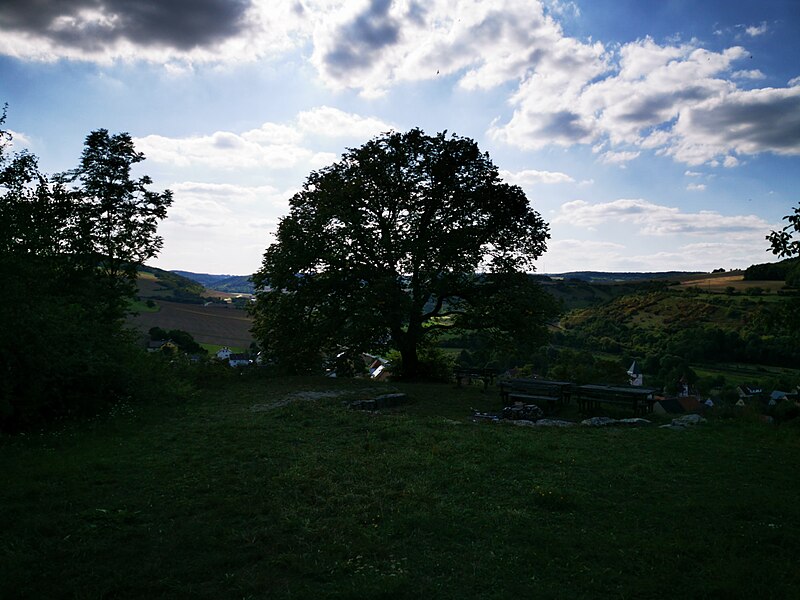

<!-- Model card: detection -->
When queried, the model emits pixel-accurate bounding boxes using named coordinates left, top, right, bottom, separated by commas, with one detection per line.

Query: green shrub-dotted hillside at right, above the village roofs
left=556, top=282, right=800, bottom=367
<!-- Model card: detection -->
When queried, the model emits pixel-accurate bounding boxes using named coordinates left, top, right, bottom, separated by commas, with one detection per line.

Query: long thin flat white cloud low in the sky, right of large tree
left=552, top=199, right=770, bottom=239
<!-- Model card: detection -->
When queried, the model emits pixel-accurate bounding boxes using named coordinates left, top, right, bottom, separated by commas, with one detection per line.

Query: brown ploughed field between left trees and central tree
left=130, top=300, right=253, bottom=348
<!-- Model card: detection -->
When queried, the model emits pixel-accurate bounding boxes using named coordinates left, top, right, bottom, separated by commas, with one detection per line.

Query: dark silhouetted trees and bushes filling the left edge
left=0, top=114, right=172, bottom=428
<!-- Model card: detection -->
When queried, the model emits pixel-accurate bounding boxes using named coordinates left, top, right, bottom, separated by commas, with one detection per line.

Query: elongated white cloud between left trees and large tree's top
left=135, top=106, right=394, bottom=170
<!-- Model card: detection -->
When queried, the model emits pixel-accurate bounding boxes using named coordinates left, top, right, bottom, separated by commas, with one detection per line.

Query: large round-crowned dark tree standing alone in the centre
left=253, top=129, right=554, bottom=377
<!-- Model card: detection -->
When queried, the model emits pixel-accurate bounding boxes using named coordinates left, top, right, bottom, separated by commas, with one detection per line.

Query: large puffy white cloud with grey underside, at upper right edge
left=489, top=30, right=800, bottom=165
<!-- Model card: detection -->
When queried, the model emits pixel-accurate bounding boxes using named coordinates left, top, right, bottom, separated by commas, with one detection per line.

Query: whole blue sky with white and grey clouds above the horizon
left=0, top=0, right=800, bottom=274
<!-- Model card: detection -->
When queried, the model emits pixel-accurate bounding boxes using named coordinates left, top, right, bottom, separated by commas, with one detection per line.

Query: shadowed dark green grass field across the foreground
left=0, top=376, right=800, bottom=599
